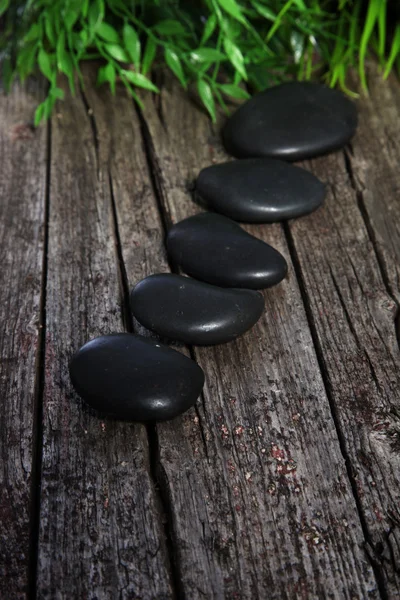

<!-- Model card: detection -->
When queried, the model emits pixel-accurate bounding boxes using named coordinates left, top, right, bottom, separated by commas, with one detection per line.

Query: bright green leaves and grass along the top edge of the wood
left=0, top=0, right=400, bottom=124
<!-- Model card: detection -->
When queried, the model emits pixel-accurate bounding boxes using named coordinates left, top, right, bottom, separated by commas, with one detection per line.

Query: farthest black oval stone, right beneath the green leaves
left=222, top=81, right=357, bottom=160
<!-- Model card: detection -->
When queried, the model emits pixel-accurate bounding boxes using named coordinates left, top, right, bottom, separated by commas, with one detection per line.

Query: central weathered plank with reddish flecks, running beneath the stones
left=134, top=74, right=379, bottom=598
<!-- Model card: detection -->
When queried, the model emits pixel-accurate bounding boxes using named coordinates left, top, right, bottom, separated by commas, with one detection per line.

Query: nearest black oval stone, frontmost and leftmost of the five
left=69, top=333, right=204, bottom=421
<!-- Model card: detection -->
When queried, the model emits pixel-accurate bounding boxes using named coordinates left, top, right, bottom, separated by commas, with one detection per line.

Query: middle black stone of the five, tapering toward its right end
left=167, top=213, right=287, bottom=290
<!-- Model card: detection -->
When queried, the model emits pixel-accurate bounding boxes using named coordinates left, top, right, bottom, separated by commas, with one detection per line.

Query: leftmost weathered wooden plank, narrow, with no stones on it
left=0, top=77, right=47, bottom=600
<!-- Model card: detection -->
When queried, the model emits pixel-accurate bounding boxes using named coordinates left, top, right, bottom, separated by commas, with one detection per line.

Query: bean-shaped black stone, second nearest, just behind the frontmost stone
left=131, top=273, right=264, bottom=345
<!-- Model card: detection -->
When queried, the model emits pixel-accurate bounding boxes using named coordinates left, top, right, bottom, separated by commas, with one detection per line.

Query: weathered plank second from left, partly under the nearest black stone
left=38, top=76, right=172, bottom=600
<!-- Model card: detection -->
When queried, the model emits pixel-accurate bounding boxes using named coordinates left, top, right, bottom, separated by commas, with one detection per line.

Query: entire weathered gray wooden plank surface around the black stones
left=0, top=63, right=400, bottom=600
